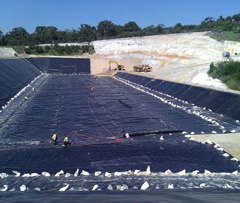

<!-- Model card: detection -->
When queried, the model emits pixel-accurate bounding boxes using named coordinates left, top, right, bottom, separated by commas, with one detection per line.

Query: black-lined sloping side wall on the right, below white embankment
left=115, top=72, right=240, bottom=120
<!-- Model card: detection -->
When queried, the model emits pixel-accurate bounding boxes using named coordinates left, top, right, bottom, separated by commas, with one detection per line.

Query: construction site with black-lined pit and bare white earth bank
left=0, top=32, right=240, bottom=198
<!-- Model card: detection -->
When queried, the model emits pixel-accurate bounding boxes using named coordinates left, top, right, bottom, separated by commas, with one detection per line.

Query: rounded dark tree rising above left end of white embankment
left=97, top=20, right=117, bottom=39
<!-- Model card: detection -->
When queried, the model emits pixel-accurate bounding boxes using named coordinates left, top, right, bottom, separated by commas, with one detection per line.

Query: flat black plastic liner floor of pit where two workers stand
left=0, top=75, right=238, bottom=173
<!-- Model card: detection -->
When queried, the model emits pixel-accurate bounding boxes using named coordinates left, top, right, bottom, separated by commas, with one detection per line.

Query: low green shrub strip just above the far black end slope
left=21, top=44, right=94, bottom=56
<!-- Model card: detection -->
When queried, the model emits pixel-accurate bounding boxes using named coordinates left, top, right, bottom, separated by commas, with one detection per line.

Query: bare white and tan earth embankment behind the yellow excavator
left=90, top=32, right=240, bottom=89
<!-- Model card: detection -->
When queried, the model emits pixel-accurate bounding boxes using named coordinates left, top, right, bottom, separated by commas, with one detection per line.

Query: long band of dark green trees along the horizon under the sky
left=0, top=14, right=240, bottom=46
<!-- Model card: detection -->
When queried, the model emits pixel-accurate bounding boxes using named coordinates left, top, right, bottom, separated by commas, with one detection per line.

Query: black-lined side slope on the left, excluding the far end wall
left=0, top=59, right=41, bottom=106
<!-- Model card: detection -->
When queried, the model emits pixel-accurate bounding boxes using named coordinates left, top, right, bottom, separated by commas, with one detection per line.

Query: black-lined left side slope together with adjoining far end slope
left=0, top=58, right=90, bottom=106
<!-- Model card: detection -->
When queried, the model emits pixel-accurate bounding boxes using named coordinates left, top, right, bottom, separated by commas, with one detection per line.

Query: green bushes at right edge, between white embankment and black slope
left=208, top=61, right=240, bottom=90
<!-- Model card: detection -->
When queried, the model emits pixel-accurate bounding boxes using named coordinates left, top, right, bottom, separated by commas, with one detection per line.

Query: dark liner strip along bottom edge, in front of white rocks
left=1, top=190, right=239, bottom=203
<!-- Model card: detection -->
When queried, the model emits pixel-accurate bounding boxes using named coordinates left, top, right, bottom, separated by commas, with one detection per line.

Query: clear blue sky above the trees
left=0, top=0, right=240, bottom=34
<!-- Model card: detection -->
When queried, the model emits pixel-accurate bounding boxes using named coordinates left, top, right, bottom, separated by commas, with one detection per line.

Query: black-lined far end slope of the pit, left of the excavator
left=26, top=57, right=91, bottom=74
